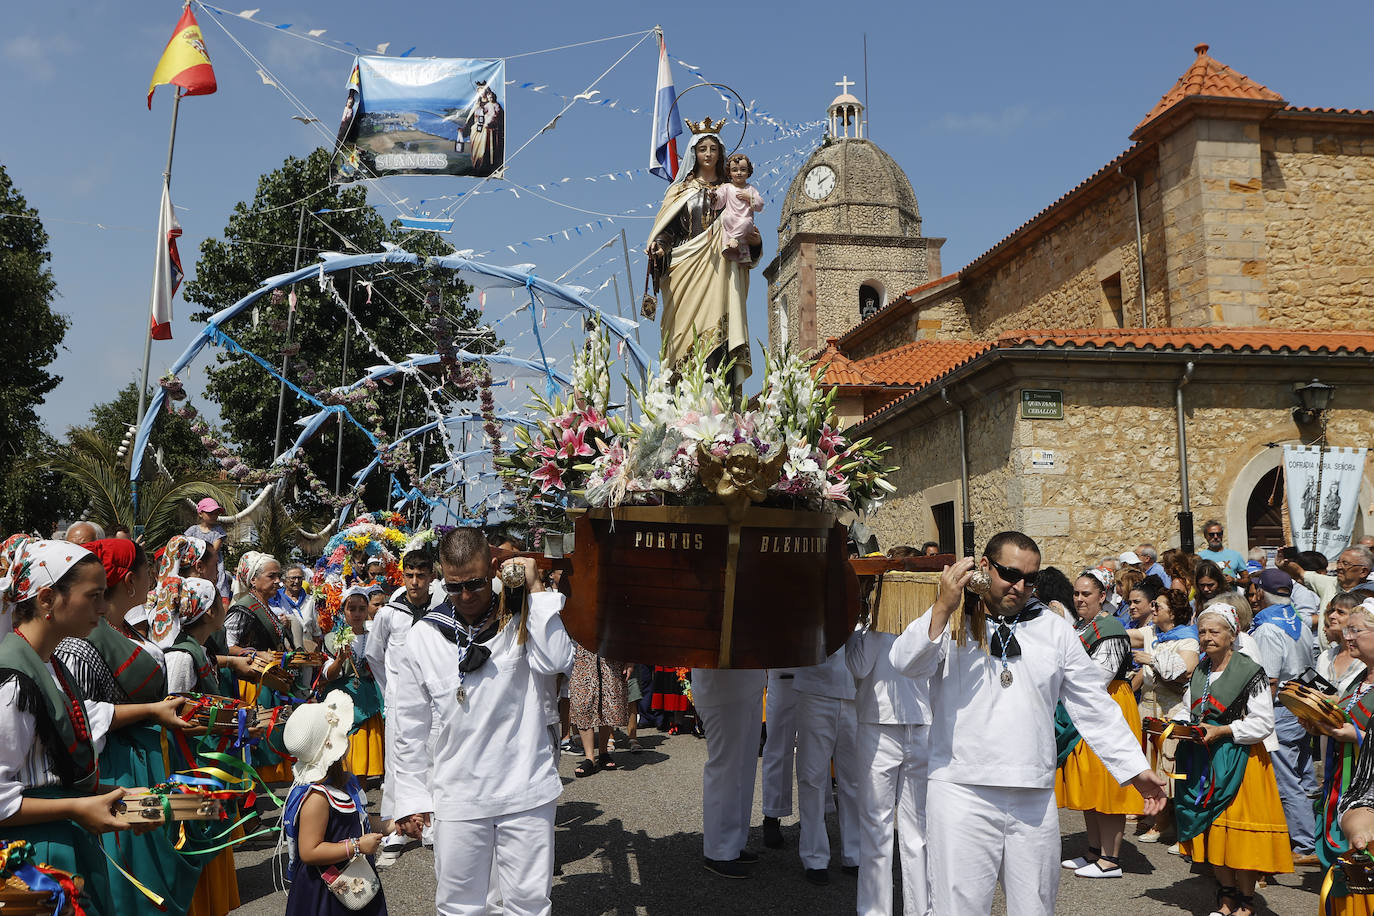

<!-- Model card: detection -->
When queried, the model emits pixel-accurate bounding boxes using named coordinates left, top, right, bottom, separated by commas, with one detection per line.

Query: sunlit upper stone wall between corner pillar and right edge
left=1260, top=129, right=1374, bottom=330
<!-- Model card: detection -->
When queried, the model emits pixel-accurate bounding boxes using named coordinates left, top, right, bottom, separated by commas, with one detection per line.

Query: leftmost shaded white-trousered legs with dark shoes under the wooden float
left=691, top=667, right=765, bottom=878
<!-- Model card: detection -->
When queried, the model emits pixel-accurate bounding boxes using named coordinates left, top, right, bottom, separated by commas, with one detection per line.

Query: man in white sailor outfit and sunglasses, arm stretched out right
left=889, top=531, right=1164, bottom=916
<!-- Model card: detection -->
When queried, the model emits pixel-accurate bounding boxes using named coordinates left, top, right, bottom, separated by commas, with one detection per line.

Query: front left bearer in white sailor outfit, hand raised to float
left=393, top=527, right=574, bottom=916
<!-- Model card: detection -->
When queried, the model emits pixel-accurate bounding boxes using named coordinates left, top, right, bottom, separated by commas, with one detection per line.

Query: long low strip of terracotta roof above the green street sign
left=998, top=327, right=1374, bottom=354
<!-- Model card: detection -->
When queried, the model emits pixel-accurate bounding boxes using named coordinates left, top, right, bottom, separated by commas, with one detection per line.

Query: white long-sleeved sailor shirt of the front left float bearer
left=392, top=592, right=573, bottom=820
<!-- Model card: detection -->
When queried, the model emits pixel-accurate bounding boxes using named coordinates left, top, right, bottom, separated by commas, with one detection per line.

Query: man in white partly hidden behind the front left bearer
left=364, top=549, right=440, bottom=868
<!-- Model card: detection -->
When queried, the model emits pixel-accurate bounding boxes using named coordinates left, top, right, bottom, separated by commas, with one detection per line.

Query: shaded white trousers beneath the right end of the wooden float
left=797, top=694, right=859, bottom=868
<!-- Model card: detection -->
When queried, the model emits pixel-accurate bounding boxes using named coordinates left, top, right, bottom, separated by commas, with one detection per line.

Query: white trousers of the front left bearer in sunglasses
left=434, top=801, right=558, bottom=916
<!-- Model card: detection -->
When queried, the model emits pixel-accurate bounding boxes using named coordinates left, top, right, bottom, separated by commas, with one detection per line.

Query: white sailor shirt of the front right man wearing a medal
left=889, top=611, right=1150, bottom=790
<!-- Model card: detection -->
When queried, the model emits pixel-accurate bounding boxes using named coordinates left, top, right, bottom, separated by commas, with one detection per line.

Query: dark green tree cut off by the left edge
left=0, top=165, right=70, bottom=533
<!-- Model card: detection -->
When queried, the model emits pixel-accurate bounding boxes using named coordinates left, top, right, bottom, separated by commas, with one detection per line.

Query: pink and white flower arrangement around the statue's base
left=497, top=318, right=896, bottom=512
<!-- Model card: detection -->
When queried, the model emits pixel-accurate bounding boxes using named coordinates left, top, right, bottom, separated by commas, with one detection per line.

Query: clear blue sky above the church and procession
left=0, top=0, right=1374, bottom=447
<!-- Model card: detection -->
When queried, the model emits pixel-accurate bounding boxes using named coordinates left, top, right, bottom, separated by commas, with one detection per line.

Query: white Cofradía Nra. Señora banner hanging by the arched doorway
left=1283, top=445, right=1364, bottom=560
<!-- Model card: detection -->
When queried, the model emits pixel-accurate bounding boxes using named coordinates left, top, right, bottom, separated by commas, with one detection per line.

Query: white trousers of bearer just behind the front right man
left=857, top=722, right=930, bottom=916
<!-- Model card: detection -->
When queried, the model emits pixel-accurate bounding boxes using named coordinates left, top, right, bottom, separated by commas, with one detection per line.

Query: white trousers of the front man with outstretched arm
left=926, top=780, right=1061, bottom=916
